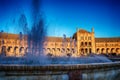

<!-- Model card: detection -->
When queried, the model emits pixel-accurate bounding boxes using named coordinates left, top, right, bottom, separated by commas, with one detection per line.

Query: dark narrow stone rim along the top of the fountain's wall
left=0, top=62, right=120, bottom=71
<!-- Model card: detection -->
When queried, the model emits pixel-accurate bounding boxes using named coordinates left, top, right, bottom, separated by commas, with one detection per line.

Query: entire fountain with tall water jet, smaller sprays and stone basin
left=0, top=0, right=120, bottom=80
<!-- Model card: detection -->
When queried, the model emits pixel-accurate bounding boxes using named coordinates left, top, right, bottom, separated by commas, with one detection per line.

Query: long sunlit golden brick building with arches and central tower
left=0, top=28, right=120, bottom=57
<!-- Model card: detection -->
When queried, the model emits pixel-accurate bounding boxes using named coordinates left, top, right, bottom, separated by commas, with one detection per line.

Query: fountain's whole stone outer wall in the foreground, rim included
left=0, top=62, right=120, bottom=80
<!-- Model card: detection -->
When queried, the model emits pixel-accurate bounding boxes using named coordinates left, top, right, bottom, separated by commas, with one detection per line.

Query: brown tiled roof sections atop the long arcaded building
left=0, top=30, right=120, bottom=42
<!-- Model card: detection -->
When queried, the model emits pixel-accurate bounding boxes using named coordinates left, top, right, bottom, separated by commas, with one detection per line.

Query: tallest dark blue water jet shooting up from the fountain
left=27, top=0, right=45, bottom=54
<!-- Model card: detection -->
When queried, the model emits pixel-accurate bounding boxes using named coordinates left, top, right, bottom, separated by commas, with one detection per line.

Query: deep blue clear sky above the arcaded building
left=0, top=0, right=120, bottom=37
